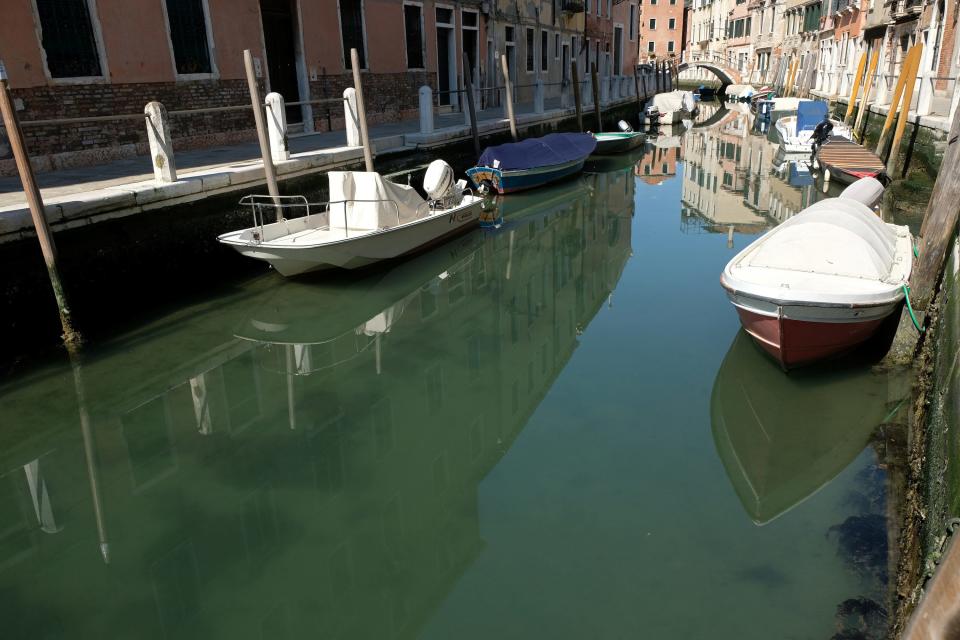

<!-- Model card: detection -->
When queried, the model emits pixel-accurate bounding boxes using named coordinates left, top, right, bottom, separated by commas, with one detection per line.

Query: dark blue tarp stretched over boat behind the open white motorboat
left=477, top=133, right=597, bottom=171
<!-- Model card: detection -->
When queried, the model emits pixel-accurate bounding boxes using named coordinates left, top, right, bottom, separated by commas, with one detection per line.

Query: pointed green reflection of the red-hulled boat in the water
left=710, top=332, right=888, bottom=525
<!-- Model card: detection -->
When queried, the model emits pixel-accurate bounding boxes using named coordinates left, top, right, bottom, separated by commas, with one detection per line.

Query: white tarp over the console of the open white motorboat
left=327, top=171, right=429, bottom=231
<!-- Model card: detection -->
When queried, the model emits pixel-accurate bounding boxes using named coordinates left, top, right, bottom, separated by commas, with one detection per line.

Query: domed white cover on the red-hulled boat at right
left=735, top=198, right=903, bottom=283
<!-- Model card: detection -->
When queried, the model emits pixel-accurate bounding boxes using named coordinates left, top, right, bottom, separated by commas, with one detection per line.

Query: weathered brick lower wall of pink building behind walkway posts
left=0, top=72, right=437, bottom=175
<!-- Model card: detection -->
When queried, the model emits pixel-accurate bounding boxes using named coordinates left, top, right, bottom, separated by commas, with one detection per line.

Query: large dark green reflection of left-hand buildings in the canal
left=0, top=170, right=634, bottom=638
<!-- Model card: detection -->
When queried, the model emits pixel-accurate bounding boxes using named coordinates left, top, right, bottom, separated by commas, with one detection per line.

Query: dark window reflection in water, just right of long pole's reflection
left=120, top=396, right=177, bottom=488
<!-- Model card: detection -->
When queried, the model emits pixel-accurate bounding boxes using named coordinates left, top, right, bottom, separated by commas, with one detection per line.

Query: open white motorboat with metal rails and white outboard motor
left=217, top=160, right=483, bottom=276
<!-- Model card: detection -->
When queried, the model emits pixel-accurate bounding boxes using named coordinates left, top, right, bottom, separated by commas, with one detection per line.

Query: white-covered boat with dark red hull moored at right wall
left=720, top=178, right=913, bottom=369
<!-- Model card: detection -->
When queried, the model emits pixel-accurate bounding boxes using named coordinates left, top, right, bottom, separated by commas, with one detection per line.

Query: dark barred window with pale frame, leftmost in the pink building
left=35, top=0, right=103, bottom=78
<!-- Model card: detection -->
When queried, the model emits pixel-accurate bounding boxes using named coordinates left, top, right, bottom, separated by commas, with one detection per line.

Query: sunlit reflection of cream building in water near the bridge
left=681, top=103, right=773, bottom=233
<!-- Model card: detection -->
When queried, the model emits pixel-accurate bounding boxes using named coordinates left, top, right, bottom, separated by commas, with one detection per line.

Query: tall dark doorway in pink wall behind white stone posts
left=260, top=0, right=303, bottom=122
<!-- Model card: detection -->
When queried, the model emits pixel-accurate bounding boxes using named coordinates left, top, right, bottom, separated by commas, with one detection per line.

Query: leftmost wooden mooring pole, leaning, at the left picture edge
left=0, top=61, right=81, bottom=350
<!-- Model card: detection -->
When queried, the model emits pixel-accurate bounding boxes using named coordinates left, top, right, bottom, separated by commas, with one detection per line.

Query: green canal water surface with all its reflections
left=0, top=107, right=899, bottom=639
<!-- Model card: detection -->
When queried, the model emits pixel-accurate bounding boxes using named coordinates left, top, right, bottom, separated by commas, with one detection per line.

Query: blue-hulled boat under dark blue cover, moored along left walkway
left=467, top=133, right=597, bottom=194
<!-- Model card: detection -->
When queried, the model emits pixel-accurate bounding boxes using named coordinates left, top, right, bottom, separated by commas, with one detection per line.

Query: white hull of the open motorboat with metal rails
left=218, top=195, right=482, bottom=276
